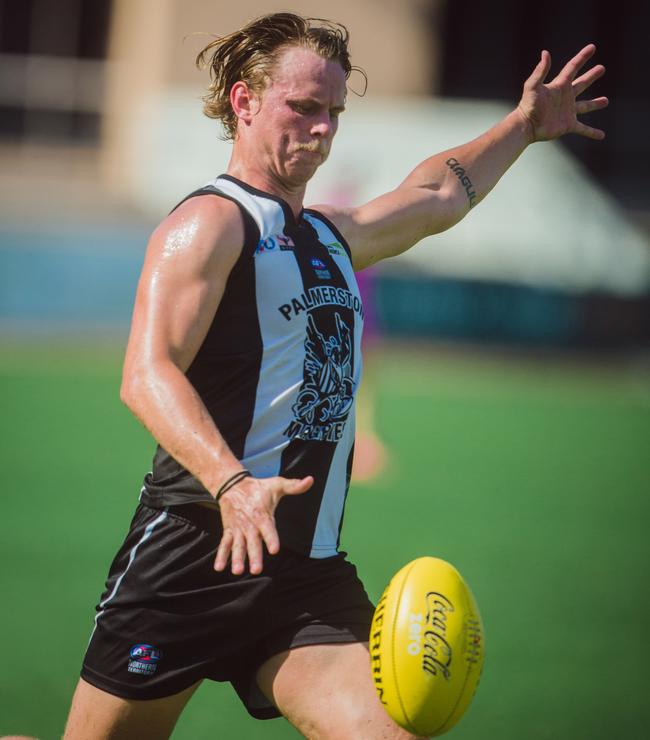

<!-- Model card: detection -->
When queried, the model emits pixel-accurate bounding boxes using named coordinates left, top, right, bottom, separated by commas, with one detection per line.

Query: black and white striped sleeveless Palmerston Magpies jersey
left=141, top=175, right=363, bottom=558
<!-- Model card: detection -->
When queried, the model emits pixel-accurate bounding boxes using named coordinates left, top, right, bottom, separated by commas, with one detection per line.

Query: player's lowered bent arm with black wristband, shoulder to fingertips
left=121, top=196, right=311, bottom=573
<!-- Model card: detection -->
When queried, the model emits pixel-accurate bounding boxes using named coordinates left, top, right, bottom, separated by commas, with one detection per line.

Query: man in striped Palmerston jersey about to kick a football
left=66, top=13, right=607, bottom=739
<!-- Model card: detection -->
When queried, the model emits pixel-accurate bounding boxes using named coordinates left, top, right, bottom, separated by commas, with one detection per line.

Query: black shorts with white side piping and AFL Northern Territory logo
left=81, top=504, right=373, bottom=719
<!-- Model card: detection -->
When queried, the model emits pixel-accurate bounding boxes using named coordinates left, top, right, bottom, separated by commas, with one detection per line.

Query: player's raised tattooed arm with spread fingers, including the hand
left=316, top=44, right=608, bottom=269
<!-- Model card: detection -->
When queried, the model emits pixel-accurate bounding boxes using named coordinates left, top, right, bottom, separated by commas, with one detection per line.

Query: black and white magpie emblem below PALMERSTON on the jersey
left=284, top=313, right=354, bottom=442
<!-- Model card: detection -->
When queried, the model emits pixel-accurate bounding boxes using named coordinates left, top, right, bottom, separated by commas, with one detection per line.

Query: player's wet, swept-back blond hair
left=196, top=13, right=365, bottom=139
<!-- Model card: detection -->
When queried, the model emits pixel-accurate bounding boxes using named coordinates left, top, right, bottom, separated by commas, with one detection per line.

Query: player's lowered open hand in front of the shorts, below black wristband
left=214, top=476, right=314, bottom=575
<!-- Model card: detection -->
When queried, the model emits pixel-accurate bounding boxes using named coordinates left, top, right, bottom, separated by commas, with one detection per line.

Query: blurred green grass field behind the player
left=0, top=345, right=650, bottom=740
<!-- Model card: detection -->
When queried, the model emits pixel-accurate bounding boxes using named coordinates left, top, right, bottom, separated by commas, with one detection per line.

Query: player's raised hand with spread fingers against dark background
left=518, top=44, right=609, bottom=141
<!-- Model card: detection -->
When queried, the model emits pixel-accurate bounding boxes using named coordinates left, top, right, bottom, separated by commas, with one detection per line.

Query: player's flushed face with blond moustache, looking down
left=239, top=47, right=346, bottom=187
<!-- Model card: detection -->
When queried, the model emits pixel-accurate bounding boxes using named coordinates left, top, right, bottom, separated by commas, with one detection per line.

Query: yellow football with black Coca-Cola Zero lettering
left=370, top=557, right=484, bottom=737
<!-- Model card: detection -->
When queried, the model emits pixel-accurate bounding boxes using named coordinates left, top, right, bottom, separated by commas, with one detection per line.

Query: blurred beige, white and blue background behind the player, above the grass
left=0, top=0, right=650, bottom=348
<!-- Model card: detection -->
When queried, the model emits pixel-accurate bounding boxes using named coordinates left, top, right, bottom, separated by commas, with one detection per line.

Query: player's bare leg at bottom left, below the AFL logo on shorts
left=64, top=678, right=199, bottom=740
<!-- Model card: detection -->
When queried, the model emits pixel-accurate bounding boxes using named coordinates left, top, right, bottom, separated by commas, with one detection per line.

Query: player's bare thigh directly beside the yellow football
left=257, top=643, right=428, bottom=740
